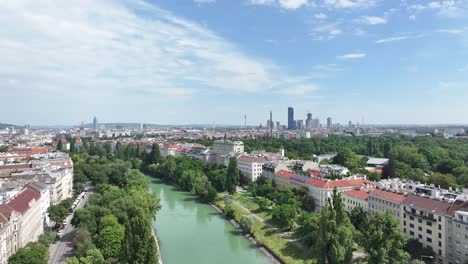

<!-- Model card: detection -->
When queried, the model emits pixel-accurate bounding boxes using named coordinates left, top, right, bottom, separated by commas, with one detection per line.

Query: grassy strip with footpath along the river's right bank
left=215, top=194, right=314, bottom=264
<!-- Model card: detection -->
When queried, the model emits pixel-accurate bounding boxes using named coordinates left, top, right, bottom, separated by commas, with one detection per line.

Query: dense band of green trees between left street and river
left=67, top=141, right=160, bottom=264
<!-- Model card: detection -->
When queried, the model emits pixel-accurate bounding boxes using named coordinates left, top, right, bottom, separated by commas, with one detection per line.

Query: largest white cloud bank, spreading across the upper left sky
left=0, top=0, right=318, bottom=121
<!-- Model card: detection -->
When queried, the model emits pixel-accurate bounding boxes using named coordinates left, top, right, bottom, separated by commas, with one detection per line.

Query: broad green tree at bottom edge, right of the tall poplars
left=364, top=211, right=409, bottom=264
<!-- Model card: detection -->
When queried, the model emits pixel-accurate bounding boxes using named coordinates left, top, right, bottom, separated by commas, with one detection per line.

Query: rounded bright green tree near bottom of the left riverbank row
left=94, top=215, right=125, bottom=259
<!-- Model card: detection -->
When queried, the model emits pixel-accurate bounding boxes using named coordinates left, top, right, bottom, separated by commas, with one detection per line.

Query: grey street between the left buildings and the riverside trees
left=49, top=191, right=93, bottom=264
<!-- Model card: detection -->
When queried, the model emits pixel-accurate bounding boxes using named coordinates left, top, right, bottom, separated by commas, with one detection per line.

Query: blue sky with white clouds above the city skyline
left=0, top=0, right=468, bottom=125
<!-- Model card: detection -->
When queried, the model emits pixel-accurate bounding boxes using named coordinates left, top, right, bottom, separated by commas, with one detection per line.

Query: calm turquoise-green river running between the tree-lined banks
left=149, top=178, right=270, bottom=264
